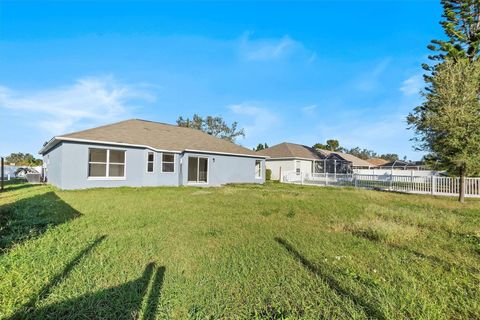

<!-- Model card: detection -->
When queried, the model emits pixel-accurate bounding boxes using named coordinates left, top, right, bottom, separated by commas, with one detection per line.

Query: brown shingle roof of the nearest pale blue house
left=44, top=119, right=258, bottom=156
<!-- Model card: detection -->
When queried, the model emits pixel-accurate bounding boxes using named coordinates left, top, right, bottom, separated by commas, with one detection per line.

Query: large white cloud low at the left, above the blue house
left=0, top=76, right=154, bottom=135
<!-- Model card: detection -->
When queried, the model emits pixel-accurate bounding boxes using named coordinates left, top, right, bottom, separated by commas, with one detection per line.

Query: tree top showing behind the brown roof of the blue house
left=177, top=114, right=245, bottom=142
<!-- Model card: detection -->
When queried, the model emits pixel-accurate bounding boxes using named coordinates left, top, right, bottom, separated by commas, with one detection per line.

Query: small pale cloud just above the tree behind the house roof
left=228, top=102, right=279, bottom=138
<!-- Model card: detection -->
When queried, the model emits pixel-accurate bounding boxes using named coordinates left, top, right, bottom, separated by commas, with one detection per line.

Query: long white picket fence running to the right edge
left=281, top=171, right=480, bottom=197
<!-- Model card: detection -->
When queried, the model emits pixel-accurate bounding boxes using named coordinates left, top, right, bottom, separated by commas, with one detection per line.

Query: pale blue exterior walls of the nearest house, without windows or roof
left=44, top=142, right=265, bottom=189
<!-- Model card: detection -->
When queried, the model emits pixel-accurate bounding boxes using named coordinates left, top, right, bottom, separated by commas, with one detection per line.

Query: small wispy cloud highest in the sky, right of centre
left=240, top=32, right=308, bottom=62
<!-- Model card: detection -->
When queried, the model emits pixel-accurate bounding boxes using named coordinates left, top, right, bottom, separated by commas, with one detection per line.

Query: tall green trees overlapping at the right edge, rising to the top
left=407, top=0, right=480, bottom=202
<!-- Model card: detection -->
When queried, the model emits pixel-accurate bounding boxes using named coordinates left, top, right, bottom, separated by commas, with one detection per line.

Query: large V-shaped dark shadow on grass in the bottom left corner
left=10, top=236, right=165, bottom=320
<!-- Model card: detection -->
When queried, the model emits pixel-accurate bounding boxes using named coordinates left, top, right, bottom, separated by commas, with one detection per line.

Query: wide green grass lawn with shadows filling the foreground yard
left=0, top=183, right=480, bottom=319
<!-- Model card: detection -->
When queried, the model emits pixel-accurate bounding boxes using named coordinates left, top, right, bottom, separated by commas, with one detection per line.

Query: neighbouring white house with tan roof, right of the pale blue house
left=257, top=142, right=372, bottom=180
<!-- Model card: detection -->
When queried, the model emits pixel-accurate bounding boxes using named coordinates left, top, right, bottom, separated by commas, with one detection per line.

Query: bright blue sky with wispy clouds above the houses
left=0, top=0, right=443, bottom=160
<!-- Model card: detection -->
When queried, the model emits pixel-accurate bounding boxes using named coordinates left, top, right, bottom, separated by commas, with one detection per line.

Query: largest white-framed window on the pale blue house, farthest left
left=88, top=148, right=125, bottom=178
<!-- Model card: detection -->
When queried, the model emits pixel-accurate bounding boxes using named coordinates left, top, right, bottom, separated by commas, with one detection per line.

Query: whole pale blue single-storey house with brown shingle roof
left=39, top=119, right=266, bottom=189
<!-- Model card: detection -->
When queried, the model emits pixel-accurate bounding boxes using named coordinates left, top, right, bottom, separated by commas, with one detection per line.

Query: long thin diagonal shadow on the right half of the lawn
left=275, top=237, right=385, bottom=319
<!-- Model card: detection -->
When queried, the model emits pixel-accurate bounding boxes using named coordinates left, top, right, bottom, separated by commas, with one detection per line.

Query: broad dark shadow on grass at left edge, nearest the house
left=0, top=192, right=80, bottom=254
